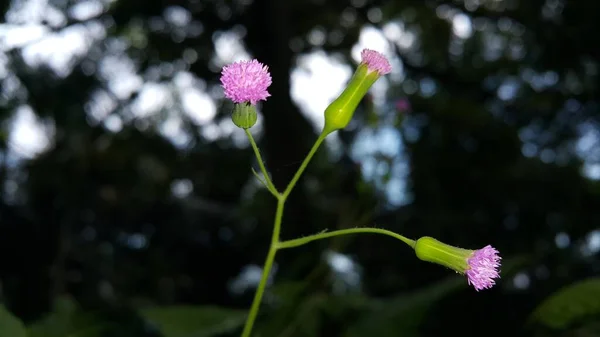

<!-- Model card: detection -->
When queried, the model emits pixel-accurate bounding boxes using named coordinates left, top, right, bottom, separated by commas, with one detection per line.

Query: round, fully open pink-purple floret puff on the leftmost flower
left=221, top=60, right=271, bottom=105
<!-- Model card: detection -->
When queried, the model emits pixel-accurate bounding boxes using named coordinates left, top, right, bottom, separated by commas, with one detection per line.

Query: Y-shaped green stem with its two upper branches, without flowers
left=242, top=130, right=327, bottom=337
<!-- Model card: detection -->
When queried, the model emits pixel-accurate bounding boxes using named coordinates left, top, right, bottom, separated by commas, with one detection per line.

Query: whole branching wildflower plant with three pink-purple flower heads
left=221, top=49, right=501, bottom=337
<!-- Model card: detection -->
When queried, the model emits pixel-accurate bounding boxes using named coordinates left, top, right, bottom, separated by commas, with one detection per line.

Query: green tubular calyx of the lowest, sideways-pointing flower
left=415, top=236, right=473, bottom=274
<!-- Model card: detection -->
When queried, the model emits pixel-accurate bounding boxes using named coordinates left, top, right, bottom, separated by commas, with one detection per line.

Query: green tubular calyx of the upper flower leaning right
left=323, top=64, right=379, bottom=134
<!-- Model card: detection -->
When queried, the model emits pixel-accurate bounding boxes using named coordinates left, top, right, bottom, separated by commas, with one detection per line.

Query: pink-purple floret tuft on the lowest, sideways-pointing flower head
left=465, top=245, right=502, bottom=291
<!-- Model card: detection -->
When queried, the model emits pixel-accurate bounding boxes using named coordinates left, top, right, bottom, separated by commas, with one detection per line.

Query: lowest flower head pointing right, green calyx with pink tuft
left=414, top=236, right=502, bottom=291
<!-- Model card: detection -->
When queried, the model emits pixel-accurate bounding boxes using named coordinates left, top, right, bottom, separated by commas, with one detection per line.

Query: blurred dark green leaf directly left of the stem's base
left=139, top=306, right=246, bottom=337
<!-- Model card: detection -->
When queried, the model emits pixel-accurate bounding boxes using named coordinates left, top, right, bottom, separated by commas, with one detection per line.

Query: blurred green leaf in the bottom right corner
left=530, top=277, right=600, bottom=329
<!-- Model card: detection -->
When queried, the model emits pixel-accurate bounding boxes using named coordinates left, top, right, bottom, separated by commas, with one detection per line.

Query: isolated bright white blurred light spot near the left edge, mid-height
left=9, top=106, right=54, bottom=158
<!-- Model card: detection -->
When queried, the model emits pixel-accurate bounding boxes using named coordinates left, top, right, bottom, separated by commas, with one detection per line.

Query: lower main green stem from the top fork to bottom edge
left=242, top=198, right=285, bottom=337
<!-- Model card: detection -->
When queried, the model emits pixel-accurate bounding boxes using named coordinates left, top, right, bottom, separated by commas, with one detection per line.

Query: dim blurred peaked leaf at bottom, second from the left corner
left=28, top=296, right=104, bottom=337
